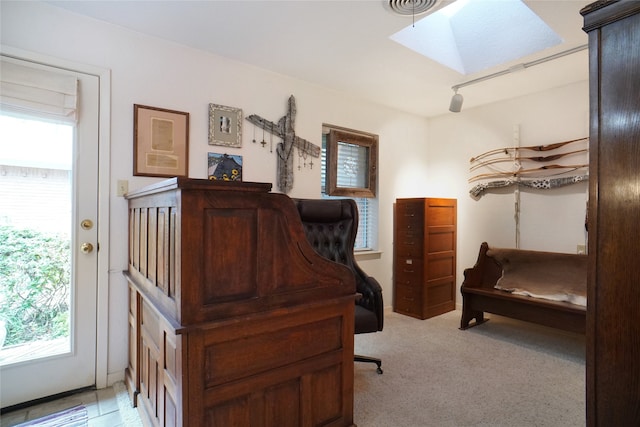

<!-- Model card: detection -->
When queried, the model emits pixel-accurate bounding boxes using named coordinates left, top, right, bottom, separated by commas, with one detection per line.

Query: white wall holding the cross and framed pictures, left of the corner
left=1, top=1, right=427, bottom=381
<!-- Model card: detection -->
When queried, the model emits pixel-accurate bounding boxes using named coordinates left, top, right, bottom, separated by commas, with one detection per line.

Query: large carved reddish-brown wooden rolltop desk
left=125, top=178, right=355, bottom=427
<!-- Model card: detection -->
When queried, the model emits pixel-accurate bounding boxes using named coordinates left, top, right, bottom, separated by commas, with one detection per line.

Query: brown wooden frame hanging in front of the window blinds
left=325, top=125, right=378, bottom=198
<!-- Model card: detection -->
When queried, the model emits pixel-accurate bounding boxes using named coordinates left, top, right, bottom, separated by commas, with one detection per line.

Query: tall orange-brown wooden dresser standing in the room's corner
left=393, top=198, right=457, bottom=319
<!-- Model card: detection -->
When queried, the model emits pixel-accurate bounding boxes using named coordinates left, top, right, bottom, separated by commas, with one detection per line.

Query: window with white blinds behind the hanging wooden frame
left=320, top=125, right=377, bottom=250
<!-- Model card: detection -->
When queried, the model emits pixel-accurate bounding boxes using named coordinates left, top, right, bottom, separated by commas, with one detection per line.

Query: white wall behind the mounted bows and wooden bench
left=425, top=81, right=589, bottom=298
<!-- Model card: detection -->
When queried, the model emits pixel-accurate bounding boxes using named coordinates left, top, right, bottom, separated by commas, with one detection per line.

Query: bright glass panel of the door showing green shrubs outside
left=0, top=115, right=73, bottom=365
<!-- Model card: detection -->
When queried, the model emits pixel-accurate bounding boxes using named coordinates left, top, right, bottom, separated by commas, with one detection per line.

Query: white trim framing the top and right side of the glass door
left=0, top=45, right=111, bottom=389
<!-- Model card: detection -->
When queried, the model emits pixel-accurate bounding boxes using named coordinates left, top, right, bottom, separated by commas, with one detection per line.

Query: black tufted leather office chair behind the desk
left=294, top=199, right=384, bottom=374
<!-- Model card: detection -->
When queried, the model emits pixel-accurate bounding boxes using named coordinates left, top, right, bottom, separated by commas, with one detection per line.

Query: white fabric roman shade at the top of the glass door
left=0, top=57, right=78, bottom=123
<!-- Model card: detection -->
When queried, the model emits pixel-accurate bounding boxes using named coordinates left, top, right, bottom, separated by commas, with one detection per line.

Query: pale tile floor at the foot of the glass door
left=0, top=383, right=143, bottom=427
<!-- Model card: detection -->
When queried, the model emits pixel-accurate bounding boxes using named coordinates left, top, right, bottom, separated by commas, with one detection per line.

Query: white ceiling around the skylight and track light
left=49, top=0, right=592, bottom=117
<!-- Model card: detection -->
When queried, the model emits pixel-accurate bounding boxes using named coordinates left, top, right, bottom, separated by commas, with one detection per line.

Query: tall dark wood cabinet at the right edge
left=581, top=1, right=640, bottom=426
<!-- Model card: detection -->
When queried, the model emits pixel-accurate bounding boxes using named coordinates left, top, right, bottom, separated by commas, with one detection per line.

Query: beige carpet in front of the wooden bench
left=354, top=311, right=586, bottom=427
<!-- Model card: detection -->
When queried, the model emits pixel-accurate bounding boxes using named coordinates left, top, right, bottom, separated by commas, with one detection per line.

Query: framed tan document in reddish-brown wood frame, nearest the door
left=133, top=104, right=189, bottom=177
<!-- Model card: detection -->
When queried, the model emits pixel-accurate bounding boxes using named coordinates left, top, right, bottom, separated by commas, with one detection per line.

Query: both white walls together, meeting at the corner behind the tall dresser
left=1, top=1, right=588, bottom=388
